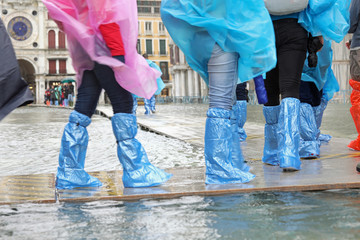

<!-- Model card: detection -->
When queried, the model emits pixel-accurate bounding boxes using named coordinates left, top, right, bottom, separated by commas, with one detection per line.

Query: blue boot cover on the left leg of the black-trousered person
left=262, top=105, right=280, bottom=166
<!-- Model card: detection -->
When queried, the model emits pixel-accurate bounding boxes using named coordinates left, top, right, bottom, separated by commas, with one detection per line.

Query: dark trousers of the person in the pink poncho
left=75, top=56, right=133, bottom=118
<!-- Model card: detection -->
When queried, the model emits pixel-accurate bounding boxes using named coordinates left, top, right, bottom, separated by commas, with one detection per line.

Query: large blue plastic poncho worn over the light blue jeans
left=161, top=0, right=276, bottom=83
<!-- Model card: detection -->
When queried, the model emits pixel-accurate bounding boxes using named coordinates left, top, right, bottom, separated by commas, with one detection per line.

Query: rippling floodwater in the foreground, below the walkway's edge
left=0, top=190, right=360, bottom=239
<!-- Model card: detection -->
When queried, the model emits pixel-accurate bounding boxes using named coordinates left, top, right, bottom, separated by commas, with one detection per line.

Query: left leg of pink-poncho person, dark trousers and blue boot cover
left=56, top=71, right=102, bottom=189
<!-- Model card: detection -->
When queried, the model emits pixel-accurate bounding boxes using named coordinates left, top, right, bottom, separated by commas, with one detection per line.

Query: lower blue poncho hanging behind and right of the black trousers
left=301, top=40, right=339, bottom=94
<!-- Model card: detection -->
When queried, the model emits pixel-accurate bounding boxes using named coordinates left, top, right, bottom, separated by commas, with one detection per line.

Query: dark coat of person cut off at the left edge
left=0, top=19, right=34, bottom=121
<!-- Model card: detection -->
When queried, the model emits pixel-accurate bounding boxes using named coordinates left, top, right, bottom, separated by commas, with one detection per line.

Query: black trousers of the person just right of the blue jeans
left=265, top=18, right=308, bottom=106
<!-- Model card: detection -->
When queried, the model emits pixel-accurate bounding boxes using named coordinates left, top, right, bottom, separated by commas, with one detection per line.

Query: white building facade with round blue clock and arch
left=1, top=0, right=75, bottom=103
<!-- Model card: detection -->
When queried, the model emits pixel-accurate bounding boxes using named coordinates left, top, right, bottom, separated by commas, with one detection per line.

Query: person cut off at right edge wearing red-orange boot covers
left=346, top=0, right=360, bottom=151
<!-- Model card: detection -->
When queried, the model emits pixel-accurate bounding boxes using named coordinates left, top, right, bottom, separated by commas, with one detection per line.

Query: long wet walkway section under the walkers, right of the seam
left=58, top=154, right=360, bottom=201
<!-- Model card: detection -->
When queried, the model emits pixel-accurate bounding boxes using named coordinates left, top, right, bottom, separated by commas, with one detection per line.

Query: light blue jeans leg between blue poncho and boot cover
left=208, top=44, right=239, bottom=110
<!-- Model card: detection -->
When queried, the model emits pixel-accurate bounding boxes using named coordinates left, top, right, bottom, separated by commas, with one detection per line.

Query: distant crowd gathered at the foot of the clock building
left=44, top=82, right=74, bottom=107
